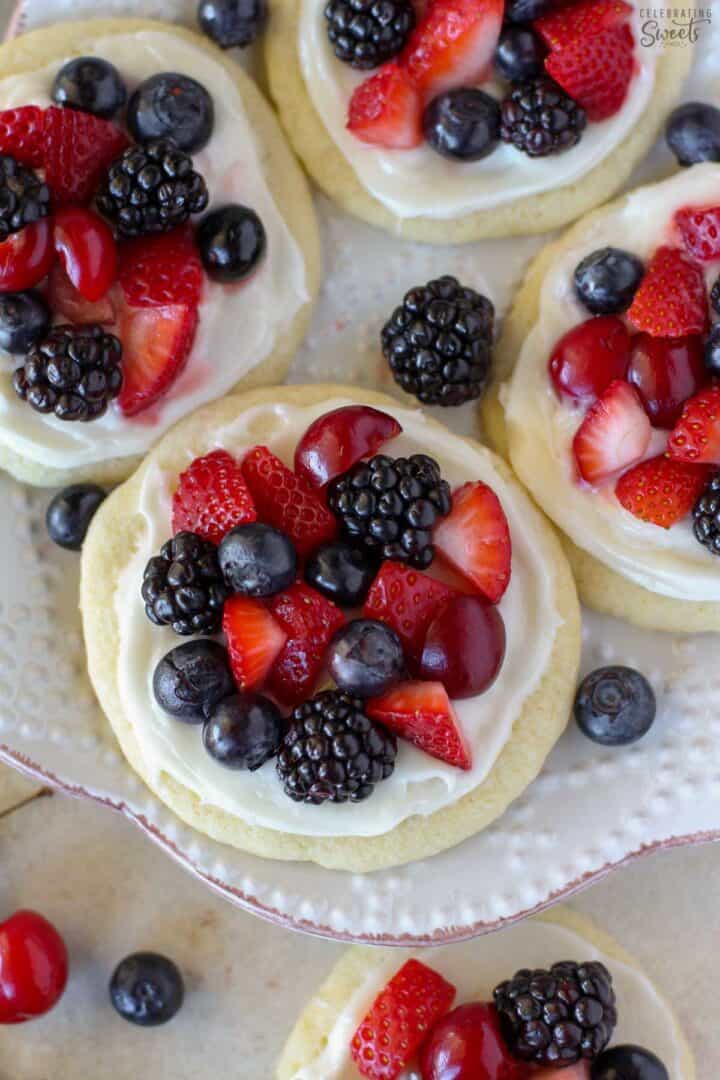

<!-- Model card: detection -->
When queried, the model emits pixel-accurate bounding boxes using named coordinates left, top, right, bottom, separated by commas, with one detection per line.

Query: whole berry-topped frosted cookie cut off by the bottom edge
left=275, top=908, right=695, bottom=1080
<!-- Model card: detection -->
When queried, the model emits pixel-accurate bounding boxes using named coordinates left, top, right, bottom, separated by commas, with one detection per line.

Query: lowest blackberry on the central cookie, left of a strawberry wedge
left=276, top=690, right=397, bottom=806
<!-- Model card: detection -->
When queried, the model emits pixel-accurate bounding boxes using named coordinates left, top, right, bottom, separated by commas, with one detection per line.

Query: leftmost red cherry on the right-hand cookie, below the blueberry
left=548, top=315, right=630, bottom=399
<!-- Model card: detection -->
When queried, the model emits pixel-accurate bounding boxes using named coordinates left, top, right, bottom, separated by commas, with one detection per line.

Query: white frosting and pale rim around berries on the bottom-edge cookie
left=293, top=919, right=689, bottom=1080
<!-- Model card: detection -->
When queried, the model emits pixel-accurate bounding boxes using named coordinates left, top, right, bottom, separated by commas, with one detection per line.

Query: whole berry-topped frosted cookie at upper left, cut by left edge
left=0, top=21, right=318, bottom=485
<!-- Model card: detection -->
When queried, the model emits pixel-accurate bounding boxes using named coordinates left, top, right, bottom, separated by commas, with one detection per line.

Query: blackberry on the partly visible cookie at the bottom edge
left=493, top=960, right=617, bottom=1065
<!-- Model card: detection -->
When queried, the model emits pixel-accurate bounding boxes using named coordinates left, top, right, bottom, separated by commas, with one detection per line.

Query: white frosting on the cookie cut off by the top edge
left=298, top=0, right=662, bottom=218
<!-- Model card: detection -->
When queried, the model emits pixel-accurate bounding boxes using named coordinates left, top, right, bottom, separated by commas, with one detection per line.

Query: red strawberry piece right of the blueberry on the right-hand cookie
left=627, top=247, right=708, bottom=337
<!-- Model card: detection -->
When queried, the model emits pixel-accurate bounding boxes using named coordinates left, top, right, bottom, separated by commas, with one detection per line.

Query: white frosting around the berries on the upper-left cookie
left=0, top=30, right=309, bottom=469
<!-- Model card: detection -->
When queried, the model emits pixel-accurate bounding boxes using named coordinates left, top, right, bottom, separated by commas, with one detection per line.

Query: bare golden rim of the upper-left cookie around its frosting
left=0, top=18, right=322, bottom=487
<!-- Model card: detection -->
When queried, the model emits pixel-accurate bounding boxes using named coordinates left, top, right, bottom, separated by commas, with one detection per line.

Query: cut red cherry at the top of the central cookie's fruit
left=295, top=405, right=403, bottom=487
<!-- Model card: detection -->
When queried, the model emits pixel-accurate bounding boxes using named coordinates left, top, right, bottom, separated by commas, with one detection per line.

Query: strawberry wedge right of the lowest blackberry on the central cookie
left=367, top=680, right=473, bottom=769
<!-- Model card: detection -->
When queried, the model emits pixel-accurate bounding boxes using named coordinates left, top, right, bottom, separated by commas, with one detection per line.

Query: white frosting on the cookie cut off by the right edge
left=503, top=164, right=720, bottom=600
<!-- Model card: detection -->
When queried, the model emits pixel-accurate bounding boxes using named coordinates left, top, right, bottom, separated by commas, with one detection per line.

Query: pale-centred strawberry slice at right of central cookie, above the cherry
left=433, top=481, right=512, bottom=604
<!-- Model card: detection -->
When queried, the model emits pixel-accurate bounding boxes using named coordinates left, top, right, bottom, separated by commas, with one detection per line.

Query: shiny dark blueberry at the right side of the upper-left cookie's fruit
left=196, top=204, right=268, bottom=282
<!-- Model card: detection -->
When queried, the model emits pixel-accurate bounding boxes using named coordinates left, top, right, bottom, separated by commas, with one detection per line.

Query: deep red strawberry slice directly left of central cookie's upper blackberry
left=243, top=446, right=337, bottom=557
